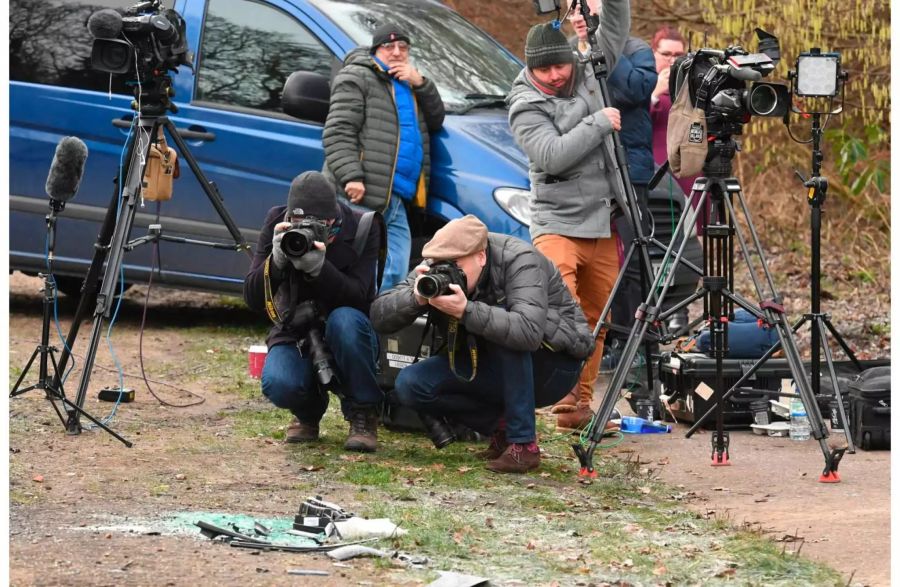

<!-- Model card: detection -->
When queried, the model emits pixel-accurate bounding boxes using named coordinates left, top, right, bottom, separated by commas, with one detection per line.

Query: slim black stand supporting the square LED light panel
left=794, top=113, right=862, bottom=446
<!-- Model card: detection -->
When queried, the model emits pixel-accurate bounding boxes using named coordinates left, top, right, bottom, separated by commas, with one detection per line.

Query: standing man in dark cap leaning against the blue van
left=322, top=24, right=444, bottom=289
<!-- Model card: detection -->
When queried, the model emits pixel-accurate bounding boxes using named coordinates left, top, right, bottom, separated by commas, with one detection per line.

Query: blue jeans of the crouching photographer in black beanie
left=262, top=307, right=383, bottom=423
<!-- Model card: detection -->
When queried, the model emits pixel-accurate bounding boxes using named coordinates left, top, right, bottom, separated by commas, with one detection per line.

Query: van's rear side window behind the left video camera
left=9, top=0, right=173, bottom=94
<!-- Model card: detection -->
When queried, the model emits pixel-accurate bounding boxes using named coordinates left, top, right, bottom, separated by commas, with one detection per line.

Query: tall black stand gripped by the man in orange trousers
left=573, top=2, right=703, bottom=396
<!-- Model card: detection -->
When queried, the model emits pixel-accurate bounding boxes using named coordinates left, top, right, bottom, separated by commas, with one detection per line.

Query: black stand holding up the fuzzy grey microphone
left=9, top=198, right=131, bottom=447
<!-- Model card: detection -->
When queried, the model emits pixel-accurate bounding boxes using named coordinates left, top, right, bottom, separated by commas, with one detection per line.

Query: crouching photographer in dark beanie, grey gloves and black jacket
left=244, top=171, right=383, bottom=452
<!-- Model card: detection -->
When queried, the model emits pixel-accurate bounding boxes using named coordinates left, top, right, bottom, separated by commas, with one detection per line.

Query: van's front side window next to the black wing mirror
left=195, top=0, right=334, bottom=112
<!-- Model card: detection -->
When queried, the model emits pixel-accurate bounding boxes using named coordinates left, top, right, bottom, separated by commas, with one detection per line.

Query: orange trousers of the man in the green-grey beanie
left=534, top=234, right=619, bottom=405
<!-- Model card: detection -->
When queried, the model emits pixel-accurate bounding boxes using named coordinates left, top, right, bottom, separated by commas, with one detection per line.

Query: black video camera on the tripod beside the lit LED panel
left=669, top=28, right=790, bottom=136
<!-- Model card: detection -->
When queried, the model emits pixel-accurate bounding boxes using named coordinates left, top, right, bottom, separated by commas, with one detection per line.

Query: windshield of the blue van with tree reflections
left=311, top=0, right=522, bottom=112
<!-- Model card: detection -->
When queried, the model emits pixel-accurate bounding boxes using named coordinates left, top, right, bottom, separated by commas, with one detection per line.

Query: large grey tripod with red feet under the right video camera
left=573, top=137, right=846, bottom=483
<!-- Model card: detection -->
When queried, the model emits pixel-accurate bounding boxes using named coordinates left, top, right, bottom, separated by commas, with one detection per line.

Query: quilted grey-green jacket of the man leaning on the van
left=322, top=47, right=444, bottom=212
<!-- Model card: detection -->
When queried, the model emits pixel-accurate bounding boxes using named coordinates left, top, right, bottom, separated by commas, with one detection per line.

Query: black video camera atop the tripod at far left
left=87, top=0, right=193, bottom=80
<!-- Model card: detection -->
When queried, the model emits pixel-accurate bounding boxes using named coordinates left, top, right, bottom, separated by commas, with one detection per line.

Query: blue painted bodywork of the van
left=10, top=0, right=529, bottom=292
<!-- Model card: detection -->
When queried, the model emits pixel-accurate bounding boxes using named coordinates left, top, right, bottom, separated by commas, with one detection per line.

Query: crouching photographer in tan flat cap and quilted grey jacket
left=370, top=215, right=594, bottom=473
